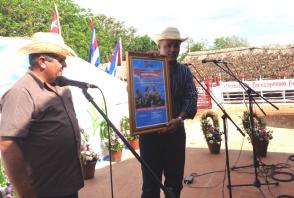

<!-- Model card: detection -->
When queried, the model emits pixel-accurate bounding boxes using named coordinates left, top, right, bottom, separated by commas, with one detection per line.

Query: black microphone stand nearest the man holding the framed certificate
left=188, top=63, right=245, bottom=198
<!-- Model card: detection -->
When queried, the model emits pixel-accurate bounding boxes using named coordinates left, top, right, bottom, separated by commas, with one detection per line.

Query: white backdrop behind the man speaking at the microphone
left=0, top=37, right=128, bottom=155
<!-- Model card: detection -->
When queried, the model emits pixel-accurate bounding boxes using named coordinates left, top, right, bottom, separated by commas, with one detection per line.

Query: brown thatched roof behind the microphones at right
left=184, top=44, right=294, bottom=80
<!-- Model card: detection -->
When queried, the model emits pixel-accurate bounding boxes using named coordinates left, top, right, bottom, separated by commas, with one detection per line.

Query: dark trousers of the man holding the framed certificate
left=140, top=128, right=186, bottom=198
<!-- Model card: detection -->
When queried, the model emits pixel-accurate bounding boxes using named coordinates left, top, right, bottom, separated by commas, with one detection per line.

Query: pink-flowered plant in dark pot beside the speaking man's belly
left=80, top=129, right=100, bottom=179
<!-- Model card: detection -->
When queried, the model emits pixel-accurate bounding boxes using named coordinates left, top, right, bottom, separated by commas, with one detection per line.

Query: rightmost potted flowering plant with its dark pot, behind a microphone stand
left=242, top=111, right=273, bottom=157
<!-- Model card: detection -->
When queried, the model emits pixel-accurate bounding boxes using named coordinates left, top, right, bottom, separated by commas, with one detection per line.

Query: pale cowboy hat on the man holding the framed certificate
left=154, top=27, right=188, bottom=44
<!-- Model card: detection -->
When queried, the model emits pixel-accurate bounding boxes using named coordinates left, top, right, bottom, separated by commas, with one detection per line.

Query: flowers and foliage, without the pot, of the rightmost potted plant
left=242, top=111, right=273, bottom=142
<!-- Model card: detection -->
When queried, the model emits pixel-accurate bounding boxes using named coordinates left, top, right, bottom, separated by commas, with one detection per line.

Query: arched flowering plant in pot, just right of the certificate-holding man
left=200, top=111, right=223, bottom=154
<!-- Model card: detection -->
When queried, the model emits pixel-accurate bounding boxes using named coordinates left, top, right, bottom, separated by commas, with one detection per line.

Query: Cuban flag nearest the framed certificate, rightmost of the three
left=105, top=39, right=122, bottom=76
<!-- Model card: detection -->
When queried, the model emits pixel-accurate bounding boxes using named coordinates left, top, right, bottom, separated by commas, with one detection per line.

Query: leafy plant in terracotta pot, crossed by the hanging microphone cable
left=99, top=120, right=124, bottom=161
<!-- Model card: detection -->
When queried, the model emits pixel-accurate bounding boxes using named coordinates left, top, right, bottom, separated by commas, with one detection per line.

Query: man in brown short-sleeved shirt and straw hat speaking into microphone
left=0, top=32, right=84, bottom=198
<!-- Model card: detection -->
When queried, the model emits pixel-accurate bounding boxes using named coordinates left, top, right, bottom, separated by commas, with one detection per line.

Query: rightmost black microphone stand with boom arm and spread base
left=207, top=61, right=279, bottom=188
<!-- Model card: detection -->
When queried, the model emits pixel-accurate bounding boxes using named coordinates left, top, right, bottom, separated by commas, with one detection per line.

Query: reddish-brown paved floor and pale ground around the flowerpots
left=79, top=104, right=294, bottom=198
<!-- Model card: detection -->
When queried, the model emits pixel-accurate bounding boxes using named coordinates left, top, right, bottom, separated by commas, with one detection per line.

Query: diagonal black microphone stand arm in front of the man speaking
left=82, top=88, right=175, bottom=198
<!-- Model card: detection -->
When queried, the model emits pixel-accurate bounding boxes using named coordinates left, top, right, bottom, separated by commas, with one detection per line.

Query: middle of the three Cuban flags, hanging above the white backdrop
left=88, top=19, right=101, bottom=67
